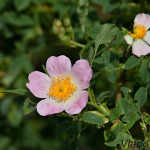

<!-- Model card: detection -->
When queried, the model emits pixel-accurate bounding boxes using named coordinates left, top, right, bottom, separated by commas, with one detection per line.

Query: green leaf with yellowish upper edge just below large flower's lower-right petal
left=81, top=111, right=108, bottom=125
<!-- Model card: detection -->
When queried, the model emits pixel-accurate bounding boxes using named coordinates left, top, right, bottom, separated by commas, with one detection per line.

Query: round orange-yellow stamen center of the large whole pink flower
left=47, top=75, right=77, bottom=101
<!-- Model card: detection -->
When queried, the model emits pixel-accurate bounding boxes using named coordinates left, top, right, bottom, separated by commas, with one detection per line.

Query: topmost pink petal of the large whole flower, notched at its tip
left=46, top=55, right=71, bottom=77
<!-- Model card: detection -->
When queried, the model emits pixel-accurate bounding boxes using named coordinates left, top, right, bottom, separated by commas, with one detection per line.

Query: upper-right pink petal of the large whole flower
left=71, top=59, right=92, bottom=89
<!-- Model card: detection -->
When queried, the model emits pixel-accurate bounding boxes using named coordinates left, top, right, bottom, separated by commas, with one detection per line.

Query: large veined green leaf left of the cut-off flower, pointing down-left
left=95, top=24, right=118, bottom=51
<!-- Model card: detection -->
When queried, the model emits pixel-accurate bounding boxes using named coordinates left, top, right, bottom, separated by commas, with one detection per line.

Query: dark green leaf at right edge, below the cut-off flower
left=139, top=60, right=149, bottom=83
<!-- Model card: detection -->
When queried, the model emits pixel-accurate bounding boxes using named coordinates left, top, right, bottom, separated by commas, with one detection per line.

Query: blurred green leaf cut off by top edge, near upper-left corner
left=14, top=0, right=30, bottom=11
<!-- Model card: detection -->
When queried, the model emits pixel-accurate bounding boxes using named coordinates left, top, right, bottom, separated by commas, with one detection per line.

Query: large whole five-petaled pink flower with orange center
left=26, top=55, right=92, bottom=116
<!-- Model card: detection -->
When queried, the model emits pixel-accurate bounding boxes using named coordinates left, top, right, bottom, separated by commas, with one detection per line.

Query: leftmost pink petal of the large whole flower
left=26, top=71, right=51, bottom=98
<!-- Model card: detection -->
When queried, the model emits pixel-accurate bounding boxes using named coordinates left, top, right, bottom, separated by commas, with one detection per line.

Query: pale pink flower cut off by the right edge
left=124, top=13, right=150, bottom=57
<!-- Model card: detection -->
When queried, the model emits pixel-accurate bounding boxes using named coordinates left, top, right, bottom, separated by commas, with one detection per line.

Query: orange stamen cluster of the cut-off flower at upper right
left=129, top=24, right=147, bottom=39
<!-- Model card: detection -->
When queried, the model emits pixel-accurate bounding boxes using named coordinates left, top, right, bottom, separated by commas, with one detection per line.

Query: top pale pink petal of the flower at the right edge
left=134, top=13, right=150, bottom=28
